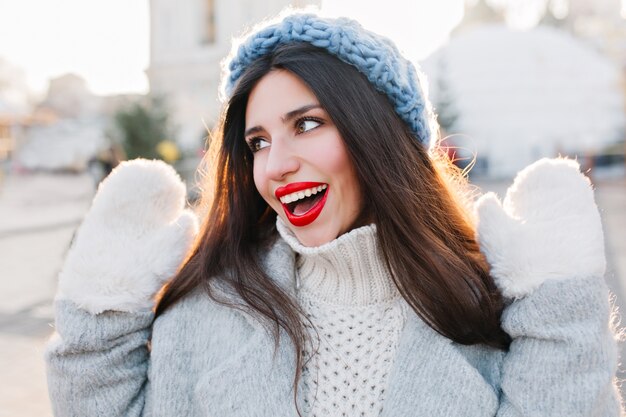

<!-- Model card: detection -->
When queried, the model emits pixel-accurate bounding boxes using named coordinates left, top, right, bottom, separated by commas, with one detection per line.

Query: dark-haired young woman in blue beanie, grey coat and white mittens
left=46, top=10, right=621, bottom=417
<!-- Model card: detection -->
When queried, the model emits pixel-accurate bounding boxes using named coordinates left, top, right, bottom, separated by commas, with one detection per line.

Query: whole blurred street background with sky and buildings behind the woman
left=0, top=0, right=626, bottom=417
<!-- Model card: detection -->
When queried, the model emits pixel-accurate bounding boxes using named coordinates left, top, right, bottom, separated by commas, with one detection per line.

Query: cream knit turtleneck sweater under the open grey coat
left=277, top=218, right=407, bottom=416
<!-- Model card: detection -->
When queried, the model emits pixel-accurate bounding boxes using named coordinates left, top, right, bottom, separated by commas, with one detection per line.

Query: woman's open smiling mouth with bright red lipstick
left=275, top=182, right=328, bottom=226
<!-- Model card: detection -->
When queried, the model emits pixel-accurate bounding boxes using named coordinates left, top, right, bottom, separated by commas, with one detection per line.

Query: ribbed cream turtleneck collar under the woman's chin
left=276, top=217, right=400, bottom=306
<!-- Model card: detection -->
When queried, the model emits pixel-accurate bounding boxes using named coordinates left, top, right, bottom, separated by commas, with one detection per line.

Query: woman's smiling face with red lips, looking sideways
left=245, top=70, right=362, bottom=246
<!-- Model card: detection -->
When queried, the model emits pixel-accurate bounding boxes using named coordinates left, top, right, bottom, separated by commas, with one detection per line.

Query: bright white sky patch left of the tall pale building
left=0, top=0, right=149, bottom=94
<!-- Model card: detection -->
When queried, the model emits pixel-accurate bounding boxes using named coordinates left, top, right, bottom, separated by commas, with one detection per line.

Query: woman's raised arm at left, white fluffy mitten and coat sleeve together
left=45, top=159, right=198, bottom=417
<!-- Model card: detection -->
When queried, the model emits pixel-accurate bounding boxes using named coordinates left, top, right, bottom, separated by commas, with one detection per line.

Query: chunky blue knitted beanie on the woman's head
left=222, top=13, right=436, bottom=148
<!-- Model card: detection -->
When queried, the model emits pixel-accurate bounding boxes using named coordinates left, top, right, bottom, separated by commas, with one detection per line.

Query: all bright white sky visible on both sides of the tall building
left=0, top=0, right=544, bottom=95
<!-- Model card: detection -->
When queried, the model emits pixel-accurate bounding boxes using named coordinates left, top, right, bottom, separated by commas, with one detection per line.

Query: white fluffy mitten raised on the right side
left=476, top=159, right=606, bottom=298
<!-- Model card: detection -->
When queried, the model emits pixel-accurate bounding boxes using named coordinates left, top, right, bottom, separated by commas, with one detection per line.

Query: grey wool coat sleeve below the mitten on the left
left=45, top=300, right=153, bottom=417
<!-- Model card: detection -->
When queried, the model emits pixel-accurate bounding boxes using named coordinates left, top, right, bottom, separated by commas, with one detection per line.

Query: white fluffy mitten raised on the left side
left=57, top=159, right=198, bottom=314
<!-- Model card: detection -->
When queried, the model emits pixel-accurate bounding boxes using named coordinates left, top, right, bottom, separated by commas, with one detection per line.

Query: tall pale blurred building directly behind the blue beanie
left=147, top=0, right=321, bottom=150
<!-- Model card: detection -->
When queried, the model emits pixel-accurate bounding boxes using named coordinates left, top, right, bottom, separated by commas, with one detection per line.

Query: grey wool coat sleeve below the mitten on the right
left=497, top=277, right=622, bottom=417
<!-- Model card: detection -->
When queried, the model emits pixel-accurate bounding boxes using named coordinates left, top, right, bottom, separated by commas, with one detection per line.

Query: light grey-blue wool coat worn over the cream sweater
left=46, top=231, right=620, bottom=417
